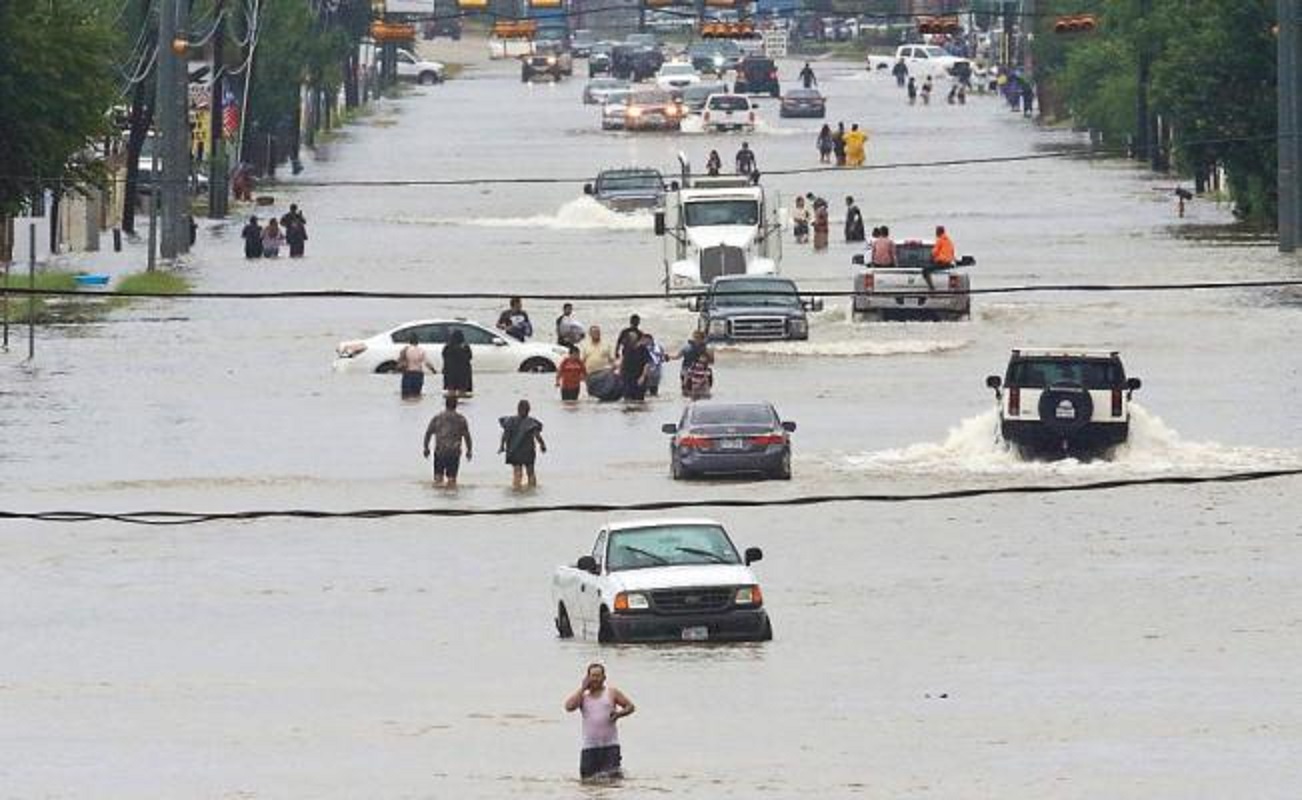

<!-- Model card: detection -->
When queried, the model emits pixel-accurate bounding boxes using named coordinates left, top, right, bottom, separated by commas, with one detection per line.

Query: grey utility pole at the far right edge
left=1276, top=0, right=1302, bottom=253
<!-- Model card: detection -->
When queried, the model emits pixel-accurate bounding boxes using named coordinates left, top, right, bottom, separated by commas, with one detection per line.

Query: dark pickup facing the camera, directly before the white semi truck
left=690, top=275, right=823, bottom=341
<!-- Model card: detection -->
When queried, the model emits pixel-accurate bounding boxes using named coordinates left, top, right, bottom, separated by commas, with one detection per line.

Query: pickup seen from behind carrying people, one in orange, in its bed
left=850, top=240, right=977, bottom=321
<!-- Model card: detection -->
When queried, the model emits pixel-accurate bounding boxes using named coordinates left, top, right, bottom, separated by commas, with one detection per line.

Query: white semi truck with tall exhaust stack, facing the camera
left=655, top=169, right=783, bottom=293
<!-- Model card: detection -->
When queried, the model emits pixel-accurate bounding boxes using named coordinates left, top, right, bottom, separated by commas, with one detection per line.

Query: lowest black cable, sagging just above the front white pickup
left=0, top=468, right=1302, bottom=526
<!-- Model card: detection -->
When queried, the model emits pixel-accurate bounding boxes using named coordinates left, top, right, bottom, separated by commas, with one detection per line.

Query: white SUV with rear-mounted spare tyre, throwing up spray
left=986, top=348, right=1142, bottom=457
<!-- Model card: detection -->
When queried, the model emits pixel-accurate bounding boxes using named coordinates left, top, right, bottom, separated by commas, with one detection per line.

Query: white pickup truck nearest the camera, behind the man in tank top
left=552, top=519, right=773, bottom=642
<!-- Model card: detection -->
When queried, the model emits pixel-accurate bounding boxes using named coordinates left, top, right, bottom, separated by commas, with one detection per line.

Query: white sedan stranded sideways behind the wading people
left=335, top=319, right=565, bottom=373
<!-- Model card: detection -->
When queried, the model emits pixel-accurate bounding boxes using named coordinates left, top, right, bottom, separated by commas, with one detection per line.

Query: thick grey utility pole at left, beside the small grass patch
left=154, top=0, right=190, bottom=258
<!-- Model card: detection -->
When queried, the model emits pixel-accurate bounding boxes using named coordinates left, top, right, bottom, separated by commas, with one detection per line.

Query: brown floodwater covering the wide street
left=0, top=51, right=1302, bottom=799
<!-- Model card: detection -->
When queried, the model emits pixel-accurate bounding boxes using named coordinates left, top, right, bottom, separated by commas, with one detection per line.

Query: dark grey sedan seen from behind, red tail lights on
left=661, top=400, right=796, bottom=481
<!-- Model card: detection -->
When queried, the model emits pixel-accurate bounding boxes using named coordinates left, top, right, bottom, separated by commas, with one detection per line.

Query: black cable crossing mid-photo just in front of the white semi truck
left=5, top=278, right=1302, bottom=302
